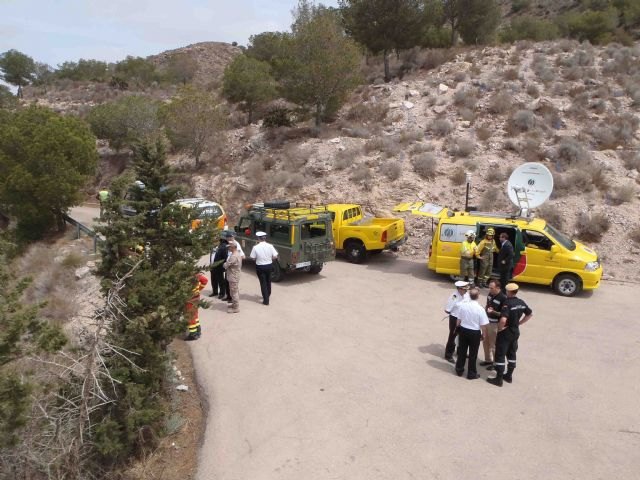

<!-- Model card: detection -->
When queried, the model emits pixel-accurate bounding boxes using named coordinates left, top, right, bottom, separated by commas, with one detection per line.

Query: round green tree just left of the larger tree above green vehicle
left=222, top=55, right=276, bottom=124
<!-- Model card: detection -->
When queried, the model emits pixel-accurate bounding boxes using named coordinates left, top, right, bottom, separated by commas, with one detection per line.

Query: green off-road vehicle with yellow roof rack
left=234, top=202, right=336, bottom=282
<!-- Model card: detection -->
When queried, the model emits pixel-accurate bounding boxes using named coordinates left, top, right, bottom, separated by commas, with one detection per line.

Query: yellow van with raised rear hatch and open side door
left=394, top=202, right=602, bottom=297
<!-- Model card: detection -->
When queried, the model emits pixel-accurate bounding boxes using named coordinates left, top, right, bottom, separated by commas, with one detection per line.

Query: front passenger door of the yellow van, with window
left=518, top=229, right=562, bottom=285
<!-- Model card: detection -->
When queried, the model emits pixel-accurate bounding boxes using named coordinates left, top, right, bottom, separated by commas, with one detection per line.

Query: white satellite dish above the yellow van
left=507, top=162, right=553, bottom=216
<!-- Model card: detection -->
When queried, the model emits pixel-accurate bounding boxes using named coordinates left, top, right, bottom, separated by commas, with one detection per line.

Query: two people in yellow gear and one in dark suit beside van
left=460, top=227, right=515, bottom=293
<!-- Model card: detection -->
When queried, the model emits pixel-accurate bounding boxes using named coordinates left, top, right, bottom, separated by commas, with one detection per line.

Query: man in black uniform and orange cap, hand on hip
left=487, top=283, right=533, bottom=387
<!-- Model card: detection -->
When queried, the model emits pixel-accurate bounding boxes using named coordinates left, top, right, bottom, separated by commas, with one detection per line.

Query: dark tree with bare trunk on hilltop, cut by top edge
left=340, top=0, right=427, bottom=82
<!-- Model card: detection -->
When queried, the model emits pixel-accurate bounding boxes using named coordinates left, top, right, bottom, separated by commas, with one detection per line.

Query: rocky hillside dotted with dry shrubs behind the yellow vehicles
left=186, top=40, right=640, bottom=280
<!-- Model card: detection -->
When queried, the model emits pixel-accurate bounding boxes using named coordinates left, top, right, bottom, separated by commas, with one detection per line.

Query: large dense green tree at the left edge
left=0, top=106, right=98, bottom=239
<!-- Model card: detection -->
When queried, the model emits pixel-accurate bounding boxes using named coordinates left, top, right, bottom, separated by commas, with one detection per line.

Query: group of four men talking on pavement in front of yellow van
left=444, top=279, right=533, bottom=387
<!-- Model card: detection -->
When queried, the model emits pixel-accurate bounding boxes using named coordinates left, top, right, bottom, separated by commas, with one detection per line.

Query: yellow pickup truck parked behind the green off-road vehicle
left=327, top=203, right=407, bottom=263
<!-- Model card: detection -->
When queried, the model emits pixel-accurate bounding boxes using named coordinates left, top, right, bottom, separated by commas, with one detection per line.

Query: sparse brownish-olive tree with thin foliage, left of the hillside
left=162, top=85, right=227, bottom=167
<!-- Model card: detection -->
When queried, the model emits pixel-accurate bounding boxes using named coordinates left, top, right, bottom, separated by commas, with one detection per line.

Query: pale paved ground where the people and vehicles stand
left=190, top=254, right=640, bottom=480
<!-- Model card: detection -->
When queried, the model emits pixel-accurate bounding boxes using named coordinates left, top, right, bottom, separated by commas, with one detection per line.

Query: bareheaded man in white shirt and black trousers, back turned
left=456, top=287, right=489, bottom=380
